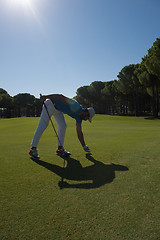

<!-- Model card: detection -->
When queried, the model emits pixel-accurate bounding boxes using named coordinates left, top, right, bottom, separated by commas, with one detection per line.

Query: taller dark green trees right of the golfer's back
left=76, top=38, right=160, bottom=117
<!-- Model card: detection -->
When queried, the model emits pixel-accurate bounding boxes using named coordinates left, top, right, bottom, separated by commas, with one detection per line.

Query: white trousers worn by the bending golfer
left=31, top=99, right=67, bottom=147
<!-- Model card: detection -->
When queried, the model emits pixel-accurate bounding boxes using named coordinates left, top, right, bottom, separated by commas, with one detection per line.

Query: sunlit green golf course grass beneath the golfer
left=0, top=115, right=160, bottom=240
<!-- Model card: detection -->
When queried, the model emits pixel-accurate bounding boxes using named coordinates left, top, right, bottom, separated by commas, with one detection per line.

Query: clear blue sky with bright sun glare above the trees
left=0, top=0, right=160, bottom=98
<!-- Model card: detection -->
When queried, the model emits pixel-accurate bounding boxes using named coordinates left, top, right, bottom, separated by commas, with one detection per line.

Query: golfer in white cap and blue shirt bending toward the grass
left=29, top=94, right=95, bottom=159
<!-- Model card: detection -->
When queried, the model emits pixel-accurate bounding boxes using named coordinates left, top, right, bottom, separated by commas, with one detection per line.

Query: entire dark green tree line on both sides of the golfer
left=0, top=38, right=160, bottom=118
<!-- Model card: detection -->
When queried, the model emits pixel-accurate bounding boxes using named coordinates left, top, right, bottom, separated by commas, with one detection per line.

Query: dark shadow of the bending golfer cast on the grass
left=33, top=154, right=129, bottom=189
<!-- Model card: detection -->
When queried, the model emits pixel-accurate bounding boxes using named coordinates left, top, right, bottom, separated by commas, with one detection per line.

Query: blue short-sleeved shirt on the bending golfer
left=53, top=99, right=83, bottom=124
